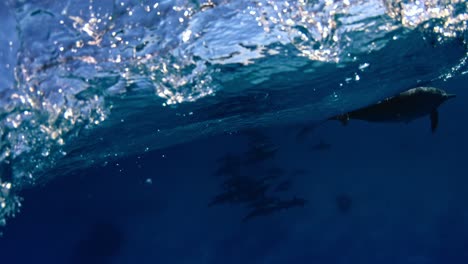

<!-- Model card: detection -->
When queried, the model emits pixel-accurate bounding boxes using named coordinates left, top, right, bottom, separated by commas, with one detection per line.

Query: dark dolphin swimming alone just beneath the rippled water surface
left=328, top=87, right=455, bottom=133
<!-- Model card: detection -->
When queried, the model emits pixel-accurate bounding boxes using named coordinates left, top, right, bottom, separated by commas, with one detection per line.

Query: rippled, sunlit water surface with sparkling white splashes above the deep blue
left=0, top=0, right=468, bottom=233
